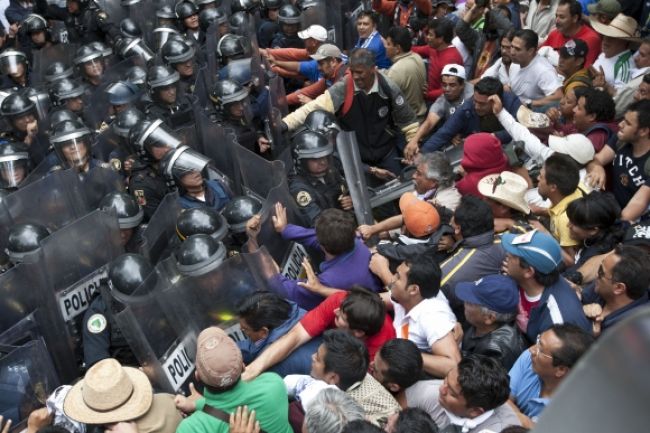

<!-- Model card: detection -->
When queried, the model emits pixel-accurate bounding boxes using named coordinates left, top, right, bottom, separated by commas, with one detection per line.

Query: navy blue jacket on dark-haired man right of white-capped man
left=420, top=92, right=521, bottom=153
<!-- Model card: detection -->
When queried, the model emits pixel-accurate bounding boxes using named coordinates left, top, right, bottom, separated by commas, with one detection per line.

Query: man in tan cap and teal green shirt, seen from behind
left=176, top=327, right=292, bottom=433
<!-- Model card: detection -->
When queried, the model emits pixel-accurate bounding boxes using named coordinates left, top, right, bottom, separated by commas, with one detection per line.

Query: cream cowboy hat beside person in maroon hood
left=478, top=171, right=530, bottom=214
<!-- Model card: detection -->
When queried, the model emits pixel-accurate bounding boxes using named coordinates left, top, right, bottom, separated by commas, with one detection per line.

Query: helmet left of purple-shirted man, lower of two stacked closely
left=175, top=234, right=226, bottom=276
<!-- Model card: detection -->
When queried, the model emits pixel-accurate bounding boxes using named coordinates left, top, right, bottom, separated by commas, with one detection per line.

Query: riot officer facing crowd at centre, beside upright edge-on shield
left=289, top=130, right=352, bottom=225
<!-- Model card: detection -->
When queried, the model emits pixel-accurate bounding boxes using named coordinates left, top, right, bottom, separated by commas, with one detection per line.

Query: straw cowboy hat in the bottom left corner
left=63, top=358, right=153, bottom=424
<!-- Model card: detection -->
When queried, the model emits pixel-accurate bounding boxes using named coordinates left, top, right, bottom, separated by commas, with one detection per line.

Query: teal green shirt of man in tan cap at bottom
left=176, top=373, right=293, bottom=433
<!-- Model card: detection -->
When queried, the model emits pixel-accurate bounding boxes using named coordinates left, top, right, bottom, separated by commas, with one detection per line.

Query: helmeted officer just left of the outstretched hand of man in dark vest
left=210, top=80, right=271, bottom=157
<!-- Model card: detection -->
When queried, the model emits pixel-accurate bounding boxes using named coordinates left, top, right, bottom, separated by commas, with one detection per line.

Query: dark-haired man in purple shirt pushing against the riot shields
left=247, top=203, right=382, bottom=310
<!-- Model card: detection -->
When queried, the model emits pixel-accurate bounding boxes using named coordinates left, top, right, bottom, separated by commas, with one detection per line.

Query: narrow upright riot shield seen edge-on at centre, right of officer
left=336, top=131, right=373, bottom=225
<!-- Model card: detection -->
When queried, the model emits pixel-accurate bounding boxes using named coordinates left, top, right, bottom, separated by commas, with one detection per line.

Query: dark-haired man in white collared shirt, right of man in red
left=370, top=254, right=460, bottom=378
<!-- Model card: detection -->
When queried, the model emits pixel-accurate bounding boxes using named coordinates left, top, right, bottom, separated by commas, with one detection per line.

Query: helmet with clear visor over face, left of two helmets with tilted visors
left=50, top=120, right=92, bottom=168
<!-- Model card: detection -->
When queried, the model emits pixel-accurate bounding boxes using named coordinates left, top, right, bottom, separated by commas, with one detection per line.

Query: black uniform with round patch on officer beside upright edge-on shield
left=289, top=169, right=347, bottom=226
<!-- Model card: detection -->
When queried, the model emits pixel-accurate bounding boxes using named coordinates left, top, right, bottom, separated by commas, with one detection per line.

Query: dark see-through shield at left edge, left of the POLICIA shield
left=0, top=262, right=78, bottom=381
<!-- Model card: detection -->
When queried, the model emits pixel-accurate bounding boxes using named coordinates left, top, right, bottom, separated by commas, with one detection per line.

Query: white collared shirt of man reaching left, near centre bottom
left=391, top=291, right=456, bottom=353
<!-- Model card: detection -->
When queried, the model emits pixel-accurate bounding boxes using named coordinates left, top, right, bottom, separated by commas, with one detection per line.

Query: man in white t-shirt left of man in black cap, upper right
left=510, top=29, right=562, bottom=108
